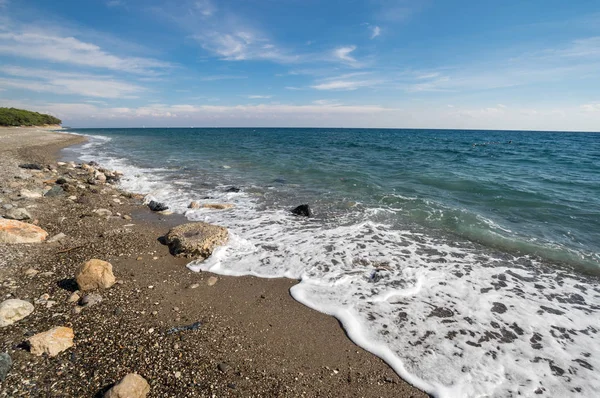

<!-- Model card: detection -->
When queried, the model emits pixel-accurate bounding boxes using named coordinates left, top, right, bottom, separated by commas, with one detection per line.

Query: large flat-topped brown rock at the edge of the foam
left=165, top=222, right=229, bottom=259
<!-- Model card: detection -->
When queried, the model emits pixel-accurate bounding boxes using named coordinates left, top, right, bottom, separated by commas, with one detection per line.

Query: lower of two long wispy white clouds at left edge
left=0, top=66, right=145, bottom=99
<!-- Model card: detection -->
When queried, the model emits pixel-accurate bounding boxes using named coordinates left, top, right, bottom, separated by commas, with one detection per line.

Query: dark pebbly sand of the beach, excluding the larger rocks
left=0, top=128, right=427, bottom=397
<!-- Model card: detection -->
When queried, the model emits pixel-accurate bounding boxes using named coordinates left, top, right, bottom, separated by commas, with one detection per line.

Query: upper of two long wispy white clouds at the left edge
left=0, top=30, right=172, bottom=75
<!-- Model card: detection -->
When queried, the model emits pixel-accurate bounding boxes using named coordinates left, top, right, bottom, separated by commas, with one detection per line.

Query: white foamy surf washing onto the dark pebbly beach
left=70, top=134, right=600, bottom=398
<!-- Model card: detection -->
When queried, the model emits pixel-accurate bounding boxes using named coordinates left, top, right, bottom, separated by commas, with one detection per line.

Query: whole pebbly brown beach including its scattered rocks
left=0, top=129, right=426, bottom=397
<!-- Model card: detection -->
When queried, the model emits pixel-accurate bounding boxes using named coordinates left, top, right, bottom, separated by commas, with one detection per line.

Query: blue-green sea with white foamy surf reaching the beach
left=59, top=128, right=600, bottom=398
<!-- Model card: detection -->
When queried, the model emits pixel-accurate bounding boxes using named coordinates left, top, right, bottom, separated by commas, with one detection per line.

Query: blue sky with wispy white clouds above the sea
left=0, top=0, right=600, bottom=131
